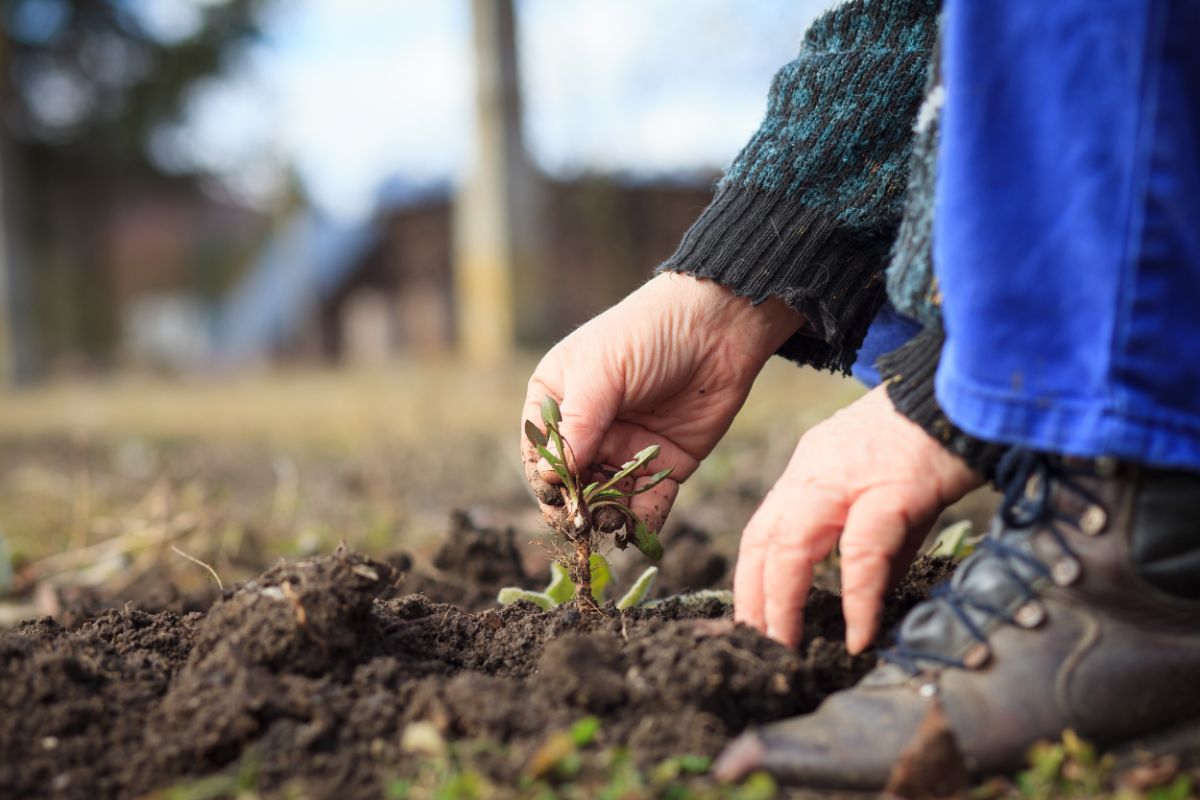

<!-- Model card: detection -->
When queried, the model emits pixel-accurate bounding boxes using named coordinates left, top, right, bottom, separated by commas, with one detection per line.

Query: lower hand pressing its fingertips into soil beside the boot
left=733, top=386, right=983, bottom=654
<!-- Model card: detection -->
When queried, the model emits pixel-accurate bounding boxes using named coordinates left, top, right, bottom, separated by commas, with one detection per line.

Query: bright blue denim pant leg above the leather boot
left=934, top=0, right=1200, bottom=470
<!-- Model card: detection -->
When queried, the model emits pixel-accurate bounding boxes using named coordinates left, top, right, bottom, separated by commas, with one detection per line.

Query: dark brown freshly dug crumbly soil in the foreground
left=0, top=525, right=947, bottom=798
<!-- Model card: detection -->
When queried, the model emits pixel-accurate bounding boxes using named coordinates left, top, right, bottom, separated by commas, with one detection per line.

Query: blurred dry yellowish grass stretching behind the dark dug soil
left=0, top=357, right=993, bottom=606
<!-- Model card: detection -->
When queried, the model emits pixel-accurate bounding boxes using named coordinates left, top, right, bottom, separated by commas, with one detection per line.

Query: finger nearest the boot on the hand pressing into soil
left=841, top=488, right=912, bottom=655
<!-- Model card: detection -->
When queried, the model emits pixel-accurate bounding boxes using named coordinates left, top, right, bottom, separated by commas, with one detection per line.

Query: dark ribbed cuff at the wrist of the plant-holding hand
left=659, top=185, right=895, bottom=373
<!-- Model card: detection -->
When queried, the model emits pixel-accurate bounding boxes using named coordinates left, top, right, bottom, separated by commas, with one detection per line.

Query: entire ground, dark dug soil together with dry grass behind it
left=0, top=365, right=1012, bottom=800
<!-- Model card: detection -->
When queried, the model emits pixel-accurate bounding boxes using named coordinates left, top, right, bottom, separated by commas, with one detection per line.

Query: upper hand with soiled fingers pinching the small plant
left=521, top=272, right=804, bottom=531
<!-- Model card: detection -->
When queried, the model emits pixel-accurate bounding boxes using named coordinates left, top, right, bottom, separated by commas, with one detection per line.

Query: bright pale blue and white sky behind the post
left=157, top=0, right=828, bottom=217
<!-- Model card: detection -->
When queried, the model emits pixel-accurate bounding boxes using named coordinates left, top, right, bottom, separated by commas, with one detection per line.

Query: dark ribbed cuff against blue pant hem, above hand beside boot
left=876, top=327, right=1007, bottom=480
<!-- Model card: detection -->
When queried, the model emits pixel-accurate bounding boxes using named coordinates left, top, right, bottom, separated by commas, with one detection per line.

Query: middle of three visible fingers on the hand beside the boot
left=762, top=476, right=846, bottom=648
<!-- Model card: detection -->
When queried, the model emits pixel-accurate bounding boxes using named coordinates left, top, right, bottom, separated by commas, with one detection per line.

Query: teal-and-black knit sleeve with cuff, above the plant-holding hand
left=659, top=0, right=937, bottom=372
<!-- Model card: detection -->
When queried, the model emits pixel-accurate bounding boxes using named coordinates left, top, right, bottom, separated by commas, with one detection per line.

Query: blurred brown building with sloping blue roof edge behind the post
left=212, top=174, right=714, bottom=363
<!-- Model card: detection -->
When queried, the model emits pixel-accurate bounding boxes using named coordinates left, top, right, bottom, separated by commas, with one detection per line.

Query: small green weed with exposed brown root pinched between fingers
left=524, top=396, right=672, bottom=612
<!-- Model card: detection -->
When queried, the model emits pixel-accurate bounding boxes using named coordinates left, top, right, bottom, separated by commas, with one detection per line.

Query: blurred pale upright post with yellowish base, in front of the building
left=454, top=0, right=542, bottom=363
